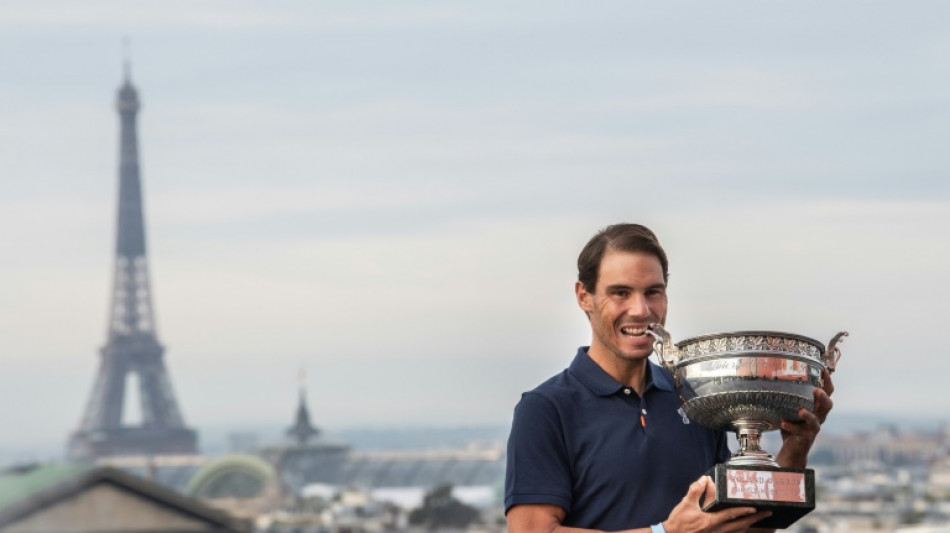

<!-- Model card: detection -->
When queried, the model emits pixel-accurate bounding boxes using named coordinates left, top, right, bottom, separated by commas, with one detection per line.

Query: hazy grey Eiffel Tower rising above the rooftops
left=68, top=65, right=197, bottom=459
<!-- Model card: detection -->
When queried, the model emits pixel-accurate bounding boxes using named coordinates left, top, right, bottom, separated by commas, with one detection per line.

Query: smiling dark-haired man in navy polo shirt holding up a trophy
left=505, top=224, right=832, bottom=533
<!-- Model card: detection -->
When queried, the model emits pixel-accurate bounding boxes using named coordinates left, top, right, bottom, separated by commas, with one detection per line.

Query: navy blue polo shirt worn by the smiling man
left=505, top=346, right=730, bottom=531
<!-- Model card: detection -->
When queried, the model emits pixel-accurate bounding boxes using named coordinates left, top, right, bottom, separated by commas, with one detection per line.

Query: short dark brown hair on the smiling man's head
left=577, top=224, right=670, bottom=292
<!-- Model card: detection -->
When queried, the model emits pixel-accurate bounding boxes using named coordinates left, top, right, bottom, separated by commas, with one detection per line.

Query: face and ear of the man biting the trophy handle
left=575, top=250, right=667, bottom=361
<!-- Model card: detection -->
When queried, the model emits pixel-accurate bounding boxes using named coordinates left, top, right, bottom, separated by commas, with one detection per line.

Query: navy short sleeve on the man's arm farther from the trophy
left=505, top=392, right=572, bottom=513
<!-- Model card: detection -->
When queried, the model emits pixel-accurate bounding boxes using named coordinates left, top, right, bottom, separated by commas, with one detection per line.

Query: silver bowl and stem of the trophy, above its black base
left=649, top=324, right=848, bottom=466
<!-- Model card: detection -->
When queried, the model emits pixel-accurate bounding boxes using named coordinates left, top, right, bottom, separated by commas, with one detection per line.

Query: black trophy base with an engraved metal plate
left=703, top=463, right=815, bottom=529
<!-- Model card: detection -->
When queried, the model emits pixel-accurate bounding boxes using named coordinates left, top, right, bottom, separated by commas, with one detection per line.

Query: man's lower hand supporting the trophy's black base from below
left=663, top=476, right=772, bottom=533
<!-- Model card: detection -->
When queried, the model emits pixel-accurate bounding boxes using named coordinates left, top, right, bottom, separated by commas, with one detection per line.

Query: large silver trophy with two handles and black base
left=649, top=324, right=848, bottom=528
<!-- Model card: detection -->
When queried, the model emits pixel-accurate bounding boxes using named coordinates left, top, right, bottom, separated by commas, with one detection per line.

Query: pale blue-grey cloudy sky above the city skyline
left=0, top=0, right=950, bottom=458
